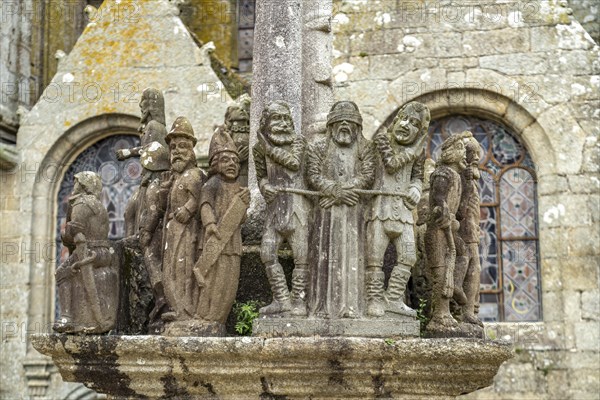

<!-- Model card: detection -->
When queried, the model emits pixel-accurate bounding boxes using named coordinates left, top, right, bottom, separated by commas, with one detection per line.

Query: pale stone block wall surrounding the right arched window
left=333, top=0, right=600, bottom=400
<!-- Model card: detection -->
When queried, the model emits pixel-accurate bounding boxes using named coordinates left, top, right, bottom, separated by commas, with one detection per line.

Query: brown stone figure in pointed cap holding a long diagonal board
left=194, top=132, right=250, bottom=335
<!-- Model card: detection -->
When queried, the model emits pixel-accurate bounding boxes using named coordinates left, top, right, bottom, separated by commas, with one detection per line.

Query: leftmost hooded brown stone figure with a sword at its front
left=53, top=171, right=119, bottom=333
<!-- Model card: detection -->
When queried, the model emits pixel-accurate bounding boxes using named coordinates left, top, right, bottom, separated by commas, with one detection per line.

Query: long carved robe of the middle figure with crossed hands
left=307, top=138, right=375, bottom=319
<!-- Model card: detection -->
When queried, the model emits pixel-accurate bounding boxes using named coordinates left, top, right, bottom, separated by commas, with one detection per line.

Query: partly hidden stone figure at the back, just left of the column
left=217, top=95, right=250, bottom=187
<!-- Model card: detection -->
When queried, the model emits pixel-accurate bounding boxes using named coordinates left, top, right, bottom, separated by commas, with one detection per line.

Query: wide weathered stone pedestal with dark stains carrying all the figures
left=32, top=334, right=512, bottom=399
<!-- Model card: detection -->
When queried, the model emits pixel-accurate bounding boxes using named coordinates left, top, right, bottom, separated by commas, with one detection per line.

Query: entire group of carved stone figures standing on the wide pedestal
left=54, top=89, right=483, bottom=337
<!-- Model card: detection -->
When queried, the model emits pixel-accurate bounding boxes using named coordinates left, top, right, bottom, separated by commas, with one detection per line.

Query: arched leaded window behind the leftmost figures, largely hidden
left=56, top=135, right=142, bottom=318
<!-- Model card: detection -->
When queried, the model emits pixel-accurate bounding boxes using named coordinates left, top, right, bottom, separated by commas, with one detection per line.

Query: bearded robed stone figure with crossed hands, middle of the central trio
left=306, top=101, right=375, bottom=319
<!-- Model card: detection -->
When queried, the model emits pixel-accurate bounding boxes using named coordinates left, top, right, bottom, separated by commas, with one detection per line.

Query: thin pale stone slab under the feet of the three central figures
left=252, top=315, right=419, bottom=338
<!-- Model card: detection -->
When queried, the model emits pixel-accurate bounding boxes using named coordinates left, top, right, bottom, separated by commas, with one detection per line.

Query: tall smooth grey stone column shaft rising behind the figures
left=248, top=0, right=302, bottom=203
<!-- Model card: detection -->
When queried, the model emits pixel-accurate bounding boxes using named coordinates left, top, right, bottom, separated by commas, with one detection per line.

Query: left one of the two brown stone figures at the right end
left=425, top=135, right=467, bottom=333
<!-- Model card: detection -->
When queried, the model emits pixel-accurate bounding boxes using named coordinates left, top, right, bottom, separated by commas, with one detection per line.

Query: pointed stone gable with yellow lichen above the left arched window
left=18, top=0, right=231, bottom=155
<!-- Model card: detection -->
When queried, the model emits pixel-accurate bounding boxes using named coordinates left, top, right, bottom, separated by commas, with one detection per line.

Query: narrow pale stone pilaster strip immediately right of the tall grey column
left=302, top=0, right=333, bottom=137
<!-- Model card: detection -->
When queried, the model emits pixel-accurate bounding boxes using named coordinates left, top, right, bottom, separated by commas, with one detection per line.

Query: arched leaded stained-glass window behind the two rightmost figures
left=427, top=115, right=542, bottom=322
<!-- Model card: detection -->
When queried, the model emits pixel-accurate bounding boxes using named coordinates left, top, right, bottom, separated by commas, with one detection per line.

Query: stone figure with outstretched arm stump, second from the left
left=117, top=88, right=170, bottom=332
